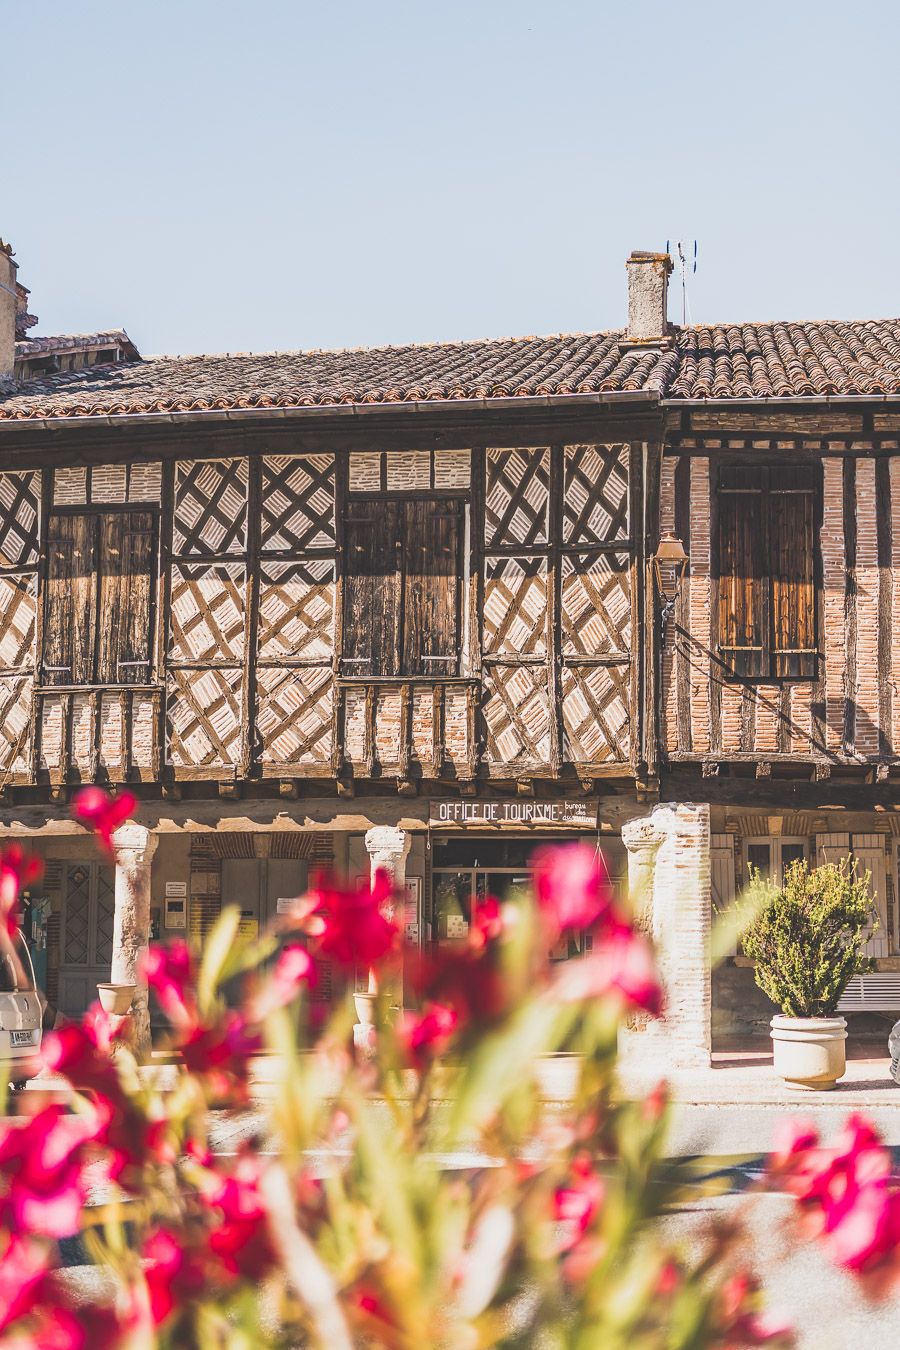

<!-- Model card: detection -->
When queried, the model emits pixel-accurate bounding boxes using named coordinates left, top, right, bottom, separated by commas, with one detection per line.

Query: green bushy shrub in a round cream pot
left=742, top=859, right=877, bottom=1091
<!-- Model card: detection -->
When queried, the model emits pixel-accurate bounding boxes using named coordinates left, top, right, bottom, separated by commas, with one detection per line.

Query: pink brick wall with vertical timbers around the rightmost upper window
left=660, top=435, right=900, bottom=763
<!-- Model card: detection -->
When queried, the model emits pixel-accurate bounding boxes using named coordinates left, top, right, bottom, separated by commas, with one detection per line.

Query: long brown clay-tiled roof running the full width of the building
left=0, top=320, right=900, bottom=419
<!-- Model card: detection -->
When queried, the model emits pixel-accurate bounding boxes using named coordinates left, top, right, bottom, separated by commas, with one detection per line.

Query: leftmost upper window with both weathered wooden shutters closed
left=43, top=510, right=155, bottom=684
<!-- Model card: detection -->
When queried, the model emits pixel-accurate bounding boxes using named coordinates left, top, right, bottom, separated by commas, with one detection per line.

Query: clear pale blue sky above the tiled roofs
left=0, top=0, right=900, bottom=352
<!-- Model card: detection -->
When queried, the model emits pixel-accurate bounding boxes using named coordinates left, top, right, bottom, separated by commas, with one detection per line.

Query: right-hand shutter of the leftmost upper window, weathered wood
left=96, top=512, right=154, bottom=684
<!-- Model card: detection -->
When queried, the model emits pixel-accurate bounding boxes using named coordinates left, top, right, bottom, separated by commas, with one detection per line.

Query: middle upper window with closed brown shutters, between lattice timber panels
left=343, top=497, right=463, bottom=676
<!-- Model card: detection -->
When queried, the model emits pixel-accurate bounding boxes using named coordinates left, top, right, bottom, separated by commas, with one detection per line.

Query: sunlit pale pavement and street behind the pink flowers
left=31, top=1040, right=900, bottom=1350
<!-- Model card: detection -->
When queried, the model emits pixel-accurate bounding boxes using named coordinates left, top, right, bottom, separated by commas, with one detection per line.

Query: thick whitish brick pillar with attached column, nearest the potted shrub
left=622, top=802, right=712, bottom=1069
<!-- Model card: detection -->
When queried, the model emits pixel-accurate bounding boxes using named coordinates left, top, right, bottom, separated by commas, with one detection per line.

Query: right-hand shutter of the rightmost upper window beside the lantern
left=768, top=467, right=816, bottom=679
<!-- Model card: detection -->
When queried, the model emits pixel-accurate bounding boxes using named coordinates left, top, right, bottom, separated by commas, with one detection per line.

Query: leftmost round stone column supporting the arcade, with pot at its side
left=109, top=825, right=157, bottom=1060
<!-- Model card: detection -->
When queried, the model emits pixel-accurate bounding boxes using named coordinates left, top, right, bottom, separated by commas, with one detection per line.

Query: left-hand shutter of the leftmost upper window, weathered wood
left=43, top=514, right=97, bottom=684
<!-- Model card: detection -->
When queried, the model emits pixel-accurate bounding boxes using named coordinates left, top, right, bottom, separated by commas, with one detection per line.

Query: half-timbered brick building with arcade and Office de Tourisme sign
left=0, top=240, right=900, bottom=1062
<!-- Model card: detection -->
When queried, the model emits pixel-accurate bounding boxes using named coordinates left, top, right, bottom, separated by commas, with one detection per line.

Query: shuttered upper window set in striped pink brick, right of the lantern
left=718, top=464, right=819, bottom=679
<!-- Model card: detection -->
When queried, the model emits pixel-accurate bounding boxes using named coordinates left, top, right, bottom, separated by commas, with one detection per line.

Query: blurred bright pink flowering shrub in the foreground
left=0, top=801, right=897, bottom=1350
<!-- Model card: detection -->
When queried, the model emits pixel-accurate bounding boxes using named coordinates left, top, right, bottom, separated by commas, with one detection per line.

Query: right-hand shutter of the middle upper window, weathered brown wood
left=402, top=500, right=460, bottom=675
